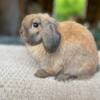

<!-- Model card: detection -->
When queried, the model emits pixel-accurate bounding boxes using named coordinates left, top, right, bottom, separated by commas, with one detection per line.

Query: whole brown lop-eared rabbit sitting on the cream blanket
left=20, top=14, right=98, bottom=80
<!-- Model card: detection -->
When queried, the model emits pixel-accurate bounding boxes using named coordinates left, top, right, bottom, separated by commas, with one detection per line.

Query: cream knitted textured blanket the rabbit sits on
left=0, top=45, right=100, bottom=100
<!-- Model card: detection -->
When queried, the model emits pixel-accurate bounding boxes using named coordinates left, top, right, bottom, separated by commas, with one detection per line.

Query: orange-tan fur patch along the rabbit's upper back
left=58, top=21, right=97, bottom=53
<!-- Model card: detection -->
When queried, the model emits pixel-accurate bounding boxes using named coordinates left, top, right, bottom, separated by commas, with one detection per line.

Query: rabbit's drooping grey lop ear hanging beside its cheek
left=42, top=18, right=60, bottom=53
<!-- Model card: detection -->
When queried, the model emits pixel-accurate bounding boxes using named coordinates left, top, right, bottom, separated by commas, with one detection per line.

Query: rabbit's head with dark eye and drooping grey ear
left=20, top=14, right=60, bottom=53
